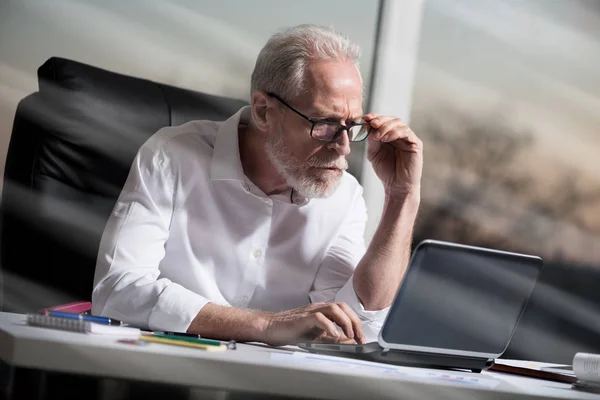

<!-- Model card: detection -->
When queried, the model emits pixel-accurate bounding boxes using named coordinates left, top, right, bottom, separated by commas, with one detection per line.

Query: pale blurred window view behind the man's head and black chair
left=0, top=0, right=379, bottom=181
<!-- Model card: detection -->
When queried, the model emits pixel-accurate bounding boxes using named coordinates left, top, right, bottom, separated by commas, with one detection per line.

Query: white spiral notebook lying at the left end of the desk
left=27, top=314, right=141, bottom=337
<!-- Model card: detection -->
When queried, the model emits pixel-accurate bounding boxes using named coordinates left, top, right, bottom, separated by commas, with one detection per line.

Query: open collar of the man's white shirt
left=210, top=106, right=309, bottom=206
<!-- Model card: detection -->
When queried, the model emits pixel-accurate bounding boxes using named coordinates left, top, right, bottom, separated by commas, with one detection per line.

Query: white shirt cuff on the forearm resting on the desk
left=148, top=283, right=208, bottom=332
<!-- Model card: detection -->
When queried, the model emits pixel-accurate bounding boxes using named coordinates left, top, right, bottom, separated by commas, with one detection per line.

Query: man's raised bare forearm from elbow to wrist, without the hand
left=353, top=192, right=420, bottom=310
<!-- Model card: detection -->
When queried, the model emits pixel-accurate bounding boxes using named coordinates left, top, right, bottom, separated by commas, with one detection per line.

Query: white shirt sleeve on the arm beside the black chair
left=92, top=138, right=208, bottom=332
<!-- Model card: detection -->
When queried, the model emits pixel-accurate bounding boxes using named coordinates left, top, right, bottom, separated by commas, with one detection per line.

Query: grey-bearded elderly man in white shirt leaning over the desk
left=92, top=25, right=423, bottom=345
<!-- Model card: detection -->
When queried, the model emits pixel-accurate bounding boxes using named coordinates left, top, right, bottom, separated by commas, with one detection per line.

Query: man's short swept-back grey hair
left=250, top=25, right=362, bottom=99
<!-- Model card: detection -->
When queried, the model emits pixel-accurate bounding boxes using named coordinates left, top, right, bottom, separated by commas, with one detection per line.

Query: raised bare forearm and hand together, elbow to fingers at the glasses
left=352, top=113, right=423, bottom=310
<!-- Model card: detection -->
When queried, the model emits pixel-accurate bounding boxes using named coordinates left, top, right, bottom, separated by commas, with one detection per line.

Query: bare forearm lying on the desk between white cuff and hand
left=188, top=303, right=267, bottom=342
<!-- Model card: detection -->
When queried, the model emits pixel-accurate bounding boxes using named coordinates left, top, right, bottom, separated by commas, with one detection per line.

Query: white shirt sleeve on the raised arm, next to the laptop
left=309, top=192, right=389, bottom=342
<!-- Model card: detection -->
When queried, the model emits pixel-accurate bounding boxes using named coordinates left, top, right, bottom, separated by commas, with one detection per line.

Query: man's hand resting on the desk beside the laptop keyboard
left=264, top=303, right=366, bottom=346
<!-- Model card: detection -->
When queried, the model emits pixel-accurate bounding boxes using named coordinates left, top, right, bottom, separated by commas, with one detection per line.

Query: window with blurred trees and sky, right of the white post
left=411, top=0, right=600, bottom=265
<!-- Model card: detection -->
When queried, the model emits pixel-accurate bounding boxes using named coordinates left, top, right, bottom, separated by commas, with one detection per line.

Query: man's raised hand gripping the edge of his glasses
left=364, top=113, right=423, bottom=195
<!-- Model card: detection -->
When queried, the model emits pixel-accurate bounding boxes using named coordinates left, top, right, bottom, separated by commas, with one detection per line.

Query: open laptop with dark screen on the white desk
left=298, top=240, right=543, bottom=372
